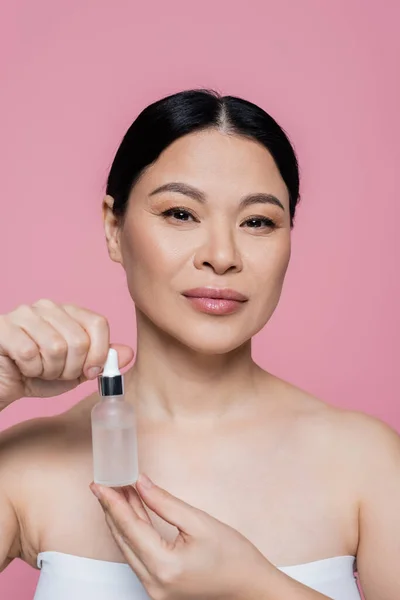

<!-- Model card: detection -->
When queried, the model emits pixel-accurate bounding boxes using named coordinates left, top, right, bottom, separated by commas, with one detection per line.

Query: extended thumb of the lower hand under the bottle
left=136, top=474, right=206, bottom=535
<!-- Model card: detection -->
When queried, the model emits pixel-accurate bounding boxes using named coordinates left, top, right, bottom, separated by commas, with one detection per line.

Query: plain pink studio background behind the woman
left=0, top=0, right=400, bottom=600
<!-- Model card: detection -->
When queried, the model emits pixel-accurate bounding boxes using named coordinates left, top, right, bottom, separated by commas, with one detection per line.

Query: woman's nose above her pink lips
left=194, top=227, right=243, bottom=275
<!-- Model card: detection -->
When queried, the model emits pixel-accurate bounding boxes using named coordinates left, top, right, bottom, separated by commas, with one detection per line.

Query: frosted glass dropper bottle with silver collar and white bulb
left=91, top=348, right=139, bottom=487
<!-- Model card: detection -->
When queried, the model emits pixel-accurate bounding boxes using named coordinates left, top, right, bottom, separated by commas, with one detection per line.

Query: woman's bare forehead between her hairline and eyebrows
left=134, top=130, right=289, bottom=205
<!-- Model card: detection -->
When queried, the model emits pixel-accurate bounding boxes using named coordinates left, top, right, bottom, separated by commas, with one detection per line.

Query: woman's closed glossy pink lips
left=183, top=288, right=248, bottom=316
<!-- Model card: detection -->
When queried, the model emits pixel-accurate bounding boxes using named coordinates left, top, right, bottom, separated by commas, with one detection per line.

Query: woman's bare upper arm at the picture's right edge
left=355, top=417, right=400, bottom=600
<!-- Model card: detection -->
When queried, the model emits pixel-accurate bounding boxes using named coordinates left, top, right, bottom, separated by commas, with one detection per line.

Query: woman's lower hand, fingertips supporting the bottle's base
left=90, top=475, right=274, bottom=600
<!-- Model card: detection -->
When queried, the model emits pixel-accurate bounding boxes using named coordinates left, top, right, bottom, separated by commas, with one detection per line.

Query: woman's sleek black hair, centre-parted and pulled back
left=106, top=89, right=300, bottom=226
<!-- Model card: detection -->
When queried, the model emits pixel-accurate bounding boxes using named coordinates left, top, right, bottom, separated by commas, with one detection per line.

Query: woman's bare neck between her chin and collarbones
left=125, top=314, right=266, bottom=424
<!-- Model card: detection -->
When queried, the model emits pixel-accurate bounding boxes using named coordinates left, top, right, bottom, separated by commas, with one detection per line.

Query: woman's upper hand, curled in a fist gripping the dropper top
left=0, top=300, right=133, bottom=410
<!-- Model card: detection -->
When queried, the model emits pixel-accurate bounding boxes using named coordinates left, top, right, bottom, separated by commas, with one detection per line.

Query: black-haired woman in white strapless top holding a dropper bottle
left=0, top=90, right=400, bottom=600
